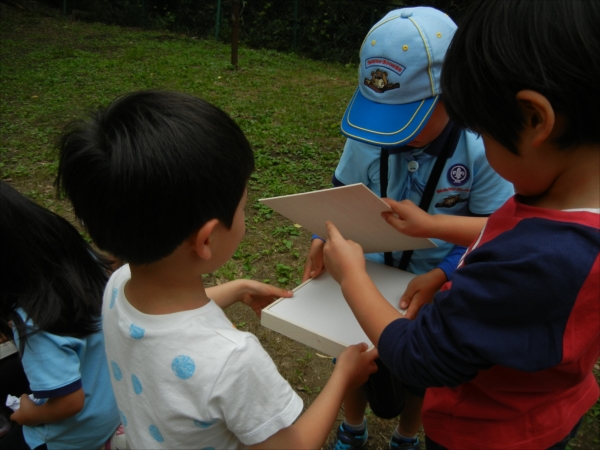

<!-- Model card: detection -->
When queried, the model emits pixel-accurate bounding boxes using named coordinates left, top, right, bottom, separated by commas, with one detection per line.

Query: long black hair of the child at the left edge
left=0, top=181, right=109, bottom=351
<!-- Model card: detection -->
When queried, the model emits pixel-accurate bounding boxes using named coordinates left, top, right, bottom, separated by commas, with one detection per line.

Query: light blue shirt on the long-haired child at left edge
left=14, top=309, right=120, bottom=450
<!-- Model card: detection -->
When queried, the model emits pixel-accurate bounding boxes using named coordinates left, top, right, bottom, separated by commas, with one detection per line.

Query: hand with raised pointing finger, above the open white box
left=323, top=221, right=365, bottom=284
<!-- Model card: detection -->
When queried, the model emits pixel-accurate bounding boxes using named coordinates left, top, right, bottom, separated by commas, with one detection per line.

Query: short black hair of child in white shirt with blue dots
left=55, top=90, right=254, bottom=264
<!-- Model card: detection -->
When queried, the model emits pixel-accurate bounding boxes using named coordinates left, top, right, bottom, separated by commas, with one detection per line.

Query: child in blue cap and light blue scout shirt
left=303, top=7, right=514, bottom=449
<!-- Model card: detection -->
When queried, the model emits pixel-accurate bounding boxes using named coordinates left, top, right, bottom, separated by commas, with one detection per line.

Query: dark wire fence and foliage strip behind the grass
left=59, top=0, right=471, bottom=62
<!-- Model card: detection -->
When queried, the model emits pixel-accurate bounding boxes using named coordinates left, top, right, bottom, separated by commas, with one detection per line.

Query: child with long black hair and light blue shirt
left=0, top=182, right=119, bottom=450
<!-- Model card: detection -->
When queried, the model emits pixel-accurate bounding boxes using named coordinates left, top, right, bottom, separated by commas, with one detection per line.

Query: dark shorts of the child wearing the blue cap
left=363, top=359, right=425, bottom=419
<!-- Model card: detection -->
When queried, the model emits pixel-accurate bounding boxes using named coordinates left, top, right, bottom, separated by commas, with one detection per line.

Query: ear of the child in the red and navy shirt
left=516, top=89, right=556, bottom=147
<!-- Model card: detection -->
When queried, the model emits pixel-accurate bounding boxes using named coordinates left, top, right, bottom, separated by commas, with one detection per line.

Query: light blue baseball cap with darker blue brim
left=341, top=7, right=457, bottom=147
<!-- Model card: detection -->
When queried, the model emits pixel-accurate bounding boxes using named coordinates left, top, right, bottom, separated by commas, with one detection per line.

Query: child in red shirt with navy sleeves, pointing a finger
left=324, top=0, right=600, bottom=450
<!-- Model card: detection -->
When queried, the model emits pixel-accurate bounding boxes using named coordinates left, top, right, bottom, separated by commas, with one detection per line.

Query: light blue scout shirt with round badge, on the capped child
left=333, top=123, right=514, bottom=275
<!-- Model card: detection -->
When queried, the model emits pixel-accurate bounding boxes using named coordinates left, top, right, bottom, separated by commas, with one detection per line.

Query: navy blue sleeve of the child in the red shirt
left=378, top=219, right=600, bottom=387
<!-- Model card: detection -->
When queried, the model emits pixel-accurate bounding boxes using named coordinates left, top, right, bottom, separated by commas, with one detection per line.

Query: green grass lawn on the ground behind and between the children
left=0, top=3, right=600, bottom=449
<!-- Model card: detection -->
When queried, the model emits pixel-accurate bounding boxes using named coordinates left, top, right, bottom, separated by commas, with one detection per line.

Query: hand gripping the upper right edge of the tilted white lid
left=381, top=198, right=435, bottom=238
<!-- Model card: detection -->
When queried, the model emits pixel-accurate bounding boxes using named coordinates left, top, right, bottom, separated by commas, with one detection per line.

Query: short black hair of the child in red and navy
left=441, top=0, right=600, bottom=153
